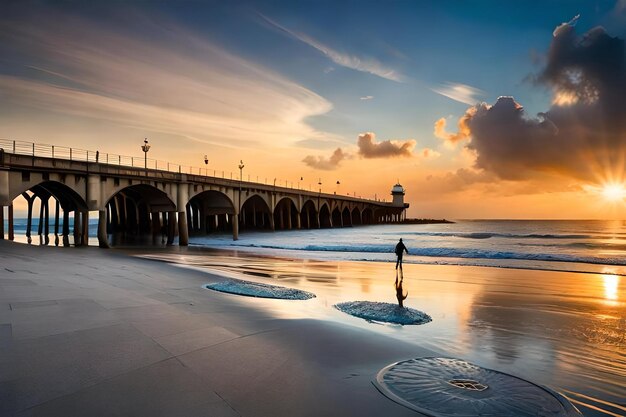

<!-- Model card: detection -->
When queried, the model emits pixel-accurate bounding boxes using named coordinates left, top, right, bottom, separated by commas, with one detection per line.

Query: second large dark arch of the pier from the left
left=105, top=184, right=177, bottom=245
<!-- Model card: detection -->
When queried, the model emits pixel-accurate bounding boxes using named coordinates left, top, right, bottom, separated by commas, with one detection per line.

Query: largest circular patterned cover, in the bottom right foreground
left=375, top=358, right=582, bottom=417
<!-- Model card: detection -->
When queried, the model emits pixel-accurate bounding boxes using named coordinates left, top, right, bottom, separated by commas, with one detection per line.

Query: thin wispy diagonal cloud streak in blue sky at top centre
left=259, top=14, right=405, bottom=82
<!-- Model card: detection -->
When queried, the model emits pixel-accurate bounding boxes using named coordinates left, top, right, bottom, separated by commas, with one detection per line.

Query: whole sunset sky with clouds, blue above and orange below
left=0, top=0, right=626, bottom=219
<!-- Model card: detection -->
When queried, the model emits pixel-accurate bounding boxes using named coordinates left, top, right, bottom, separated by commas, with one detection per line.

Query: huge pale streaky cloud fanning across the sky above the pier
left=0, top=11, right=332, bottom=149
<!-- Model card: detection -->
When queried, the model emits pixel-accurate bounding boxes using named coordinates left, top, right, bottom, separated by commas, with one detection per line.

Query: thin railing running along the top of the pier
left=0, top=138, right=383, bottom=202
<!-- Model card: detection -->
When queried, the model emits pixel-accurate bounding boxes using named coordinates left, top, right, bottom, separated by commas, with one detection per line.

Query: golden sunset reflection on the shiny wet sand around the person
left=143, top=251, right=626, bottom=410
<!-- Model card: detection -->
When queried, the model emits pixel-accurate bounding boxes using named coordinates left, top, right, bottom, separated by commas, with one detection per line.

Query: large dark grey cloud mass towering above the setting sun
left=435, top=22, right=626, bottom=183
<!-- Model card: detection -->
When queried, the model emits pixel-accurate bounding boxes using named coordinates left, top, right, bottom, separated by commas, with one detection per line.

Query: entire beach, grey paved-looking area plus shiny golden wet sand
left=0, top=237, right=625, bottom=416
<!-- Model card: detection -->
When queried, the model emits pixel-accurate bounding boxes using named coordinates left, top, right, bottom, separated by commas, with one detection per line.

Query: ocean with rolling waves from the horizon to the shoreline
left=190, top=220, right=626, bottom=275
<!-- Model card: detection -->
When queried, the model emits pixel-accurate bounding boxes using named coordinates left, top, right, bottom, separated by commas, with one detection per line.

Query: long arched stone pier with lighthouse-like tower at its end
left=0, top=139, right=409, bottom=247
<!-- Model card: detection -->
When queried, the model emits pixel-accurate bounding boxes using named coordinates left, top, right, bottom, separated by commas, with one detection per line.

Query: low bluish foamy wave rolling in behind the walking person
left=207, top=243, right=626, bottom=266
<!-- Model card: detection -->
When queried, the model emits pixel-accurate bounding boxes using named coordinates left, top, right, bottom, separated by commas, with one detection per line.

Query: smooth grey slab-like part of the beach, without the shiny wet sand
left=0, top=242, right=432, bottom=416
